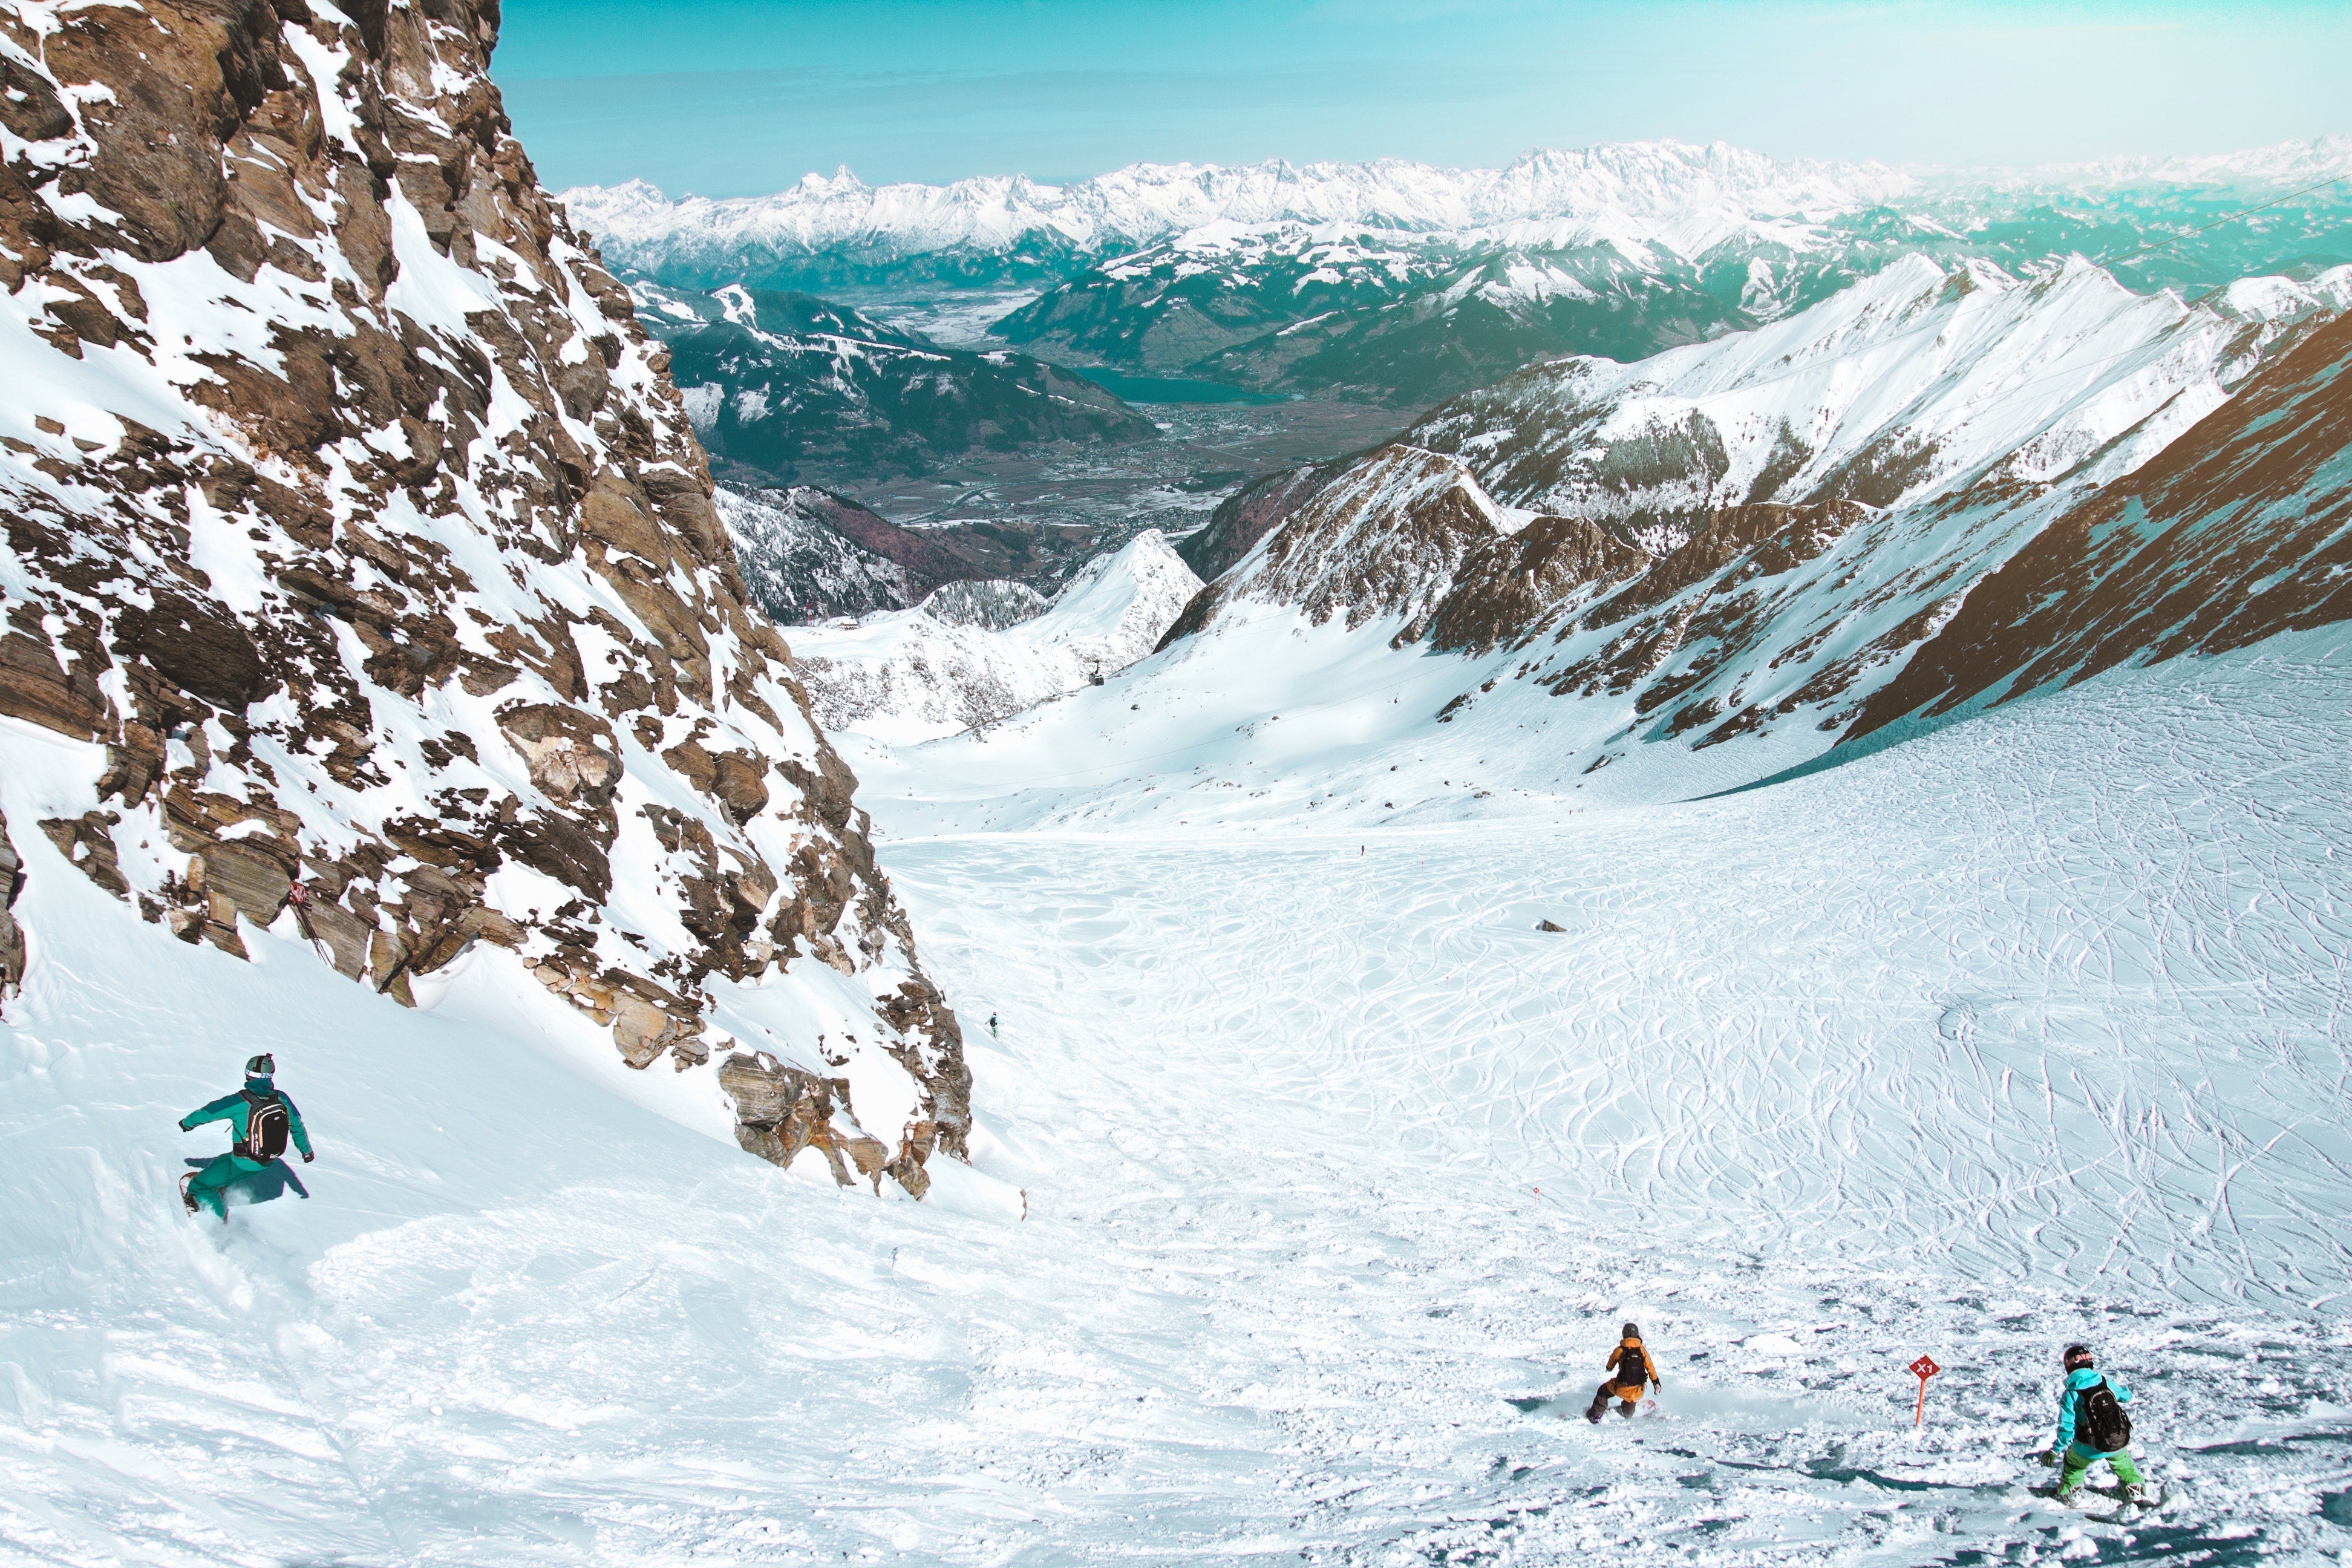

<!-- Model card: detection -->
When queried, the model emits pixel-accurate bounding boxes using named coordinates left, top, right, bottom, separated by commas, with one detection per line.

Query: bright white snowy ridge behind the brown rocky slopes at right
left=1409, top=256, right=2352, bottom=536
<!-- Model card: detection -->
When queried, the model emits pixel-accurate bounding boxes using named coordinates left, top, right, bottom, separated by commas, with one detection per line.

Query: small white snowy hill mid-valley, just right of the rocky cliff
left=792, top=529, right=1202, bottom=743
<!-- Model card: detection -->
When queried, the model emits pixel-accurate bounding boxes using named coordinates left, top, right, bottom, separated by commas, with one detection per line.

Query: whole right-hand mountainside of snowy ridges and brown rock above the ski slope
left=1016, top=261, right=2352, bottom=808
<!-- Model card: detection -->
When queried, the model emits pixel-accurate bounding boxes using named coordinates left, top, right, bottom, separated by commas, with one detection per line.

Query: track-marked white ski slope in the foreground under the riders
left=0, top=637, right=2352, bottom=1566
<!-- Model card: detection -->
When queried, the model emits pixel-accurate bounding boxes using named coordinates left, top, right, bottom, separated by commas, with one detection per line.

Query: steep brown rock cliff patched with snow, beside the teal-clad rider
left=0, top=0, right=969, bottom=1192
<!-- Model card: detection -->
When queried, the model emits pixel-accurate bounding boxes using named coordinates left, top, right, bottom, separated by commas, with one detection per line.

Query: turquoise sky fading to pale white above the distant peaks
left=494, top=0, right=2352, bottom=195
